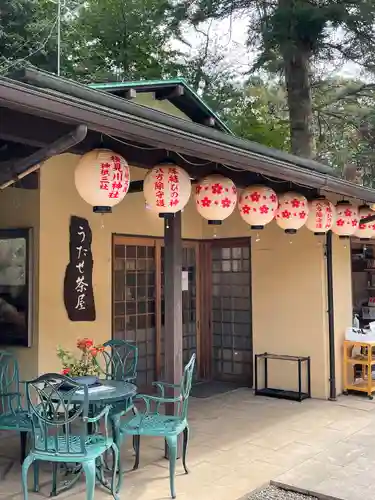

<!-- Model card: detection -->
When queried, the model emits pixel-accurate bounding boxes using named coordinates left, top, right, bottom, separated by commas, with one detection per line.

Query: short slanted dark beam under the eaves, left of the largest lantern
left=0, top=125, right=87, bottom=189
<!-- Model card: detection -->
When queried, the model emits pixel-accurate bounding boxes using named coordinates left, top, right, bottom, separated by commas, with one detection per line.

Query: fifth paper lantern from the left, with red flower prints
left=275, top=191, right=309, bottom=234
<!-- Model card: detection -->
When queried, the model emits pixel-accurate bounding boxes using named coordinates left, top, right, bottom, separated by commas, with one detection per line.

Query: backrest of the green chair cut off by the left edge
left=0, top=351, right=21, bottom=414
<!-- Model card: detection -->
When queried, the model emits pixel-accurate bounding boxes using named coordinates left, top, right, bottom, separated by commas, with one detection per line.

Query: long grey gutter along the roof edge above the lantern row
left=16, top=68, right=337, bottom=176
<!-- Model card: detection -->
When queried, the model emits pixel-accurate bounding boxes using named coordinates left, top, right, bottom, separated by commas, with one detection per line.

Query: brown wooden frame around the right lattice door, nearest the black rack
left=200, top=236, right=254, bottom=380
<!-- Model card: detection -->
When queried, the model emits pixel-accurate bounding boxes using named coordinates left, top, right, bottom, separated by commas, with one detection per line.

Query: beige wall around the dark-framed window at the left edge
left=0, top=188, right=39, bottom=380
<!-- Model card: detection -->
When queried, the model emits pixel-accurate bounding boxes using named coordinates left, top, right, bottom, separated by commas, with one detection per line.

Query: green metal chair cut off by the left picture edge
left=0, top=351, right=31, bottom=464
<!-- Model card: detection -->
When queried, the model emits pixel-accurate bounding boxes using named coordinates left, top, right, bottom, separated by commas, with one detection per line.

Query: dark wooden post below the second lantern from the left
left=164, top=212, right=182, bottom=457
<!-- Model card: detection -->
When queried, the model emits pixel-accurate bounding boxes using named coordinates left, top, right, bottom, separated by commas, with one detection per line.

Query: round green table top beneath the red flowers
left=71, top=380, right=137, bottom=404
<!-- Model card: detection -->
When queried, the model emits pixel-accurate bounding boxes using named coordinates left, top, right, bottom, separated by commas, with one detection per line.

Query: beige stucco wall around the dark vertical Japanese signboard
left=39, top=154, right=202, bottom=372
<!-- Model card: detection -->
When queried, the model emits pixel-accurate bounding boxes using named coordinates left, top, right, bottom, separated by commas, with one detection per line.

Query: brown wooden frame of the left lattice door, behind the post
left=111, top=233, right=202, bottom=379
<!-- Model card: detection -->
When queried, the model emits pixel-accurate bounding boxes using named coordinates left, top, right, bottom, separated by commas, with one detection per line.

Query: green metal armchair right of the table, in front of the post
left=119, top=354, right=195, bottom=498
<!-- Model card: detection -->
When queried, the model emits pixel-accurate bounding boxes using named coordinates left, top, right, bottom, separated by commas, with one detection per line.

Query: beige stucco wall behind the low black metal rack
left=204, top=212, right=328, bottom=398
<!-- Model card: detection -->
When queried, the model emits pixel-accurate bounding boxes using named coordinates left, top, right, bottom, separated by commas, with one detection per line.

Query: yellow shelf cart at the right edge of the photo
left=343, top=340, right=375, bottom=399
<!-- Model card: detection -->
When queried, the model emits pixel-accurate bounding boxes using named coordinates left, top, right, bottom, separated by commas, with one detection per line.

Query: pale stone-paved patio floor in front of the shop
left=0, top=389, right=375, bottom=500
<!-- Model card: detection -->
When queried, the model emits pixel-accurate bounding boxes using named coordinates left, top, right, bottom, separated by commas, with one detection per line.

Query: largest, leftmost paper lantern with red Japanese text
left=74, top=149, right=130, bottom=213
